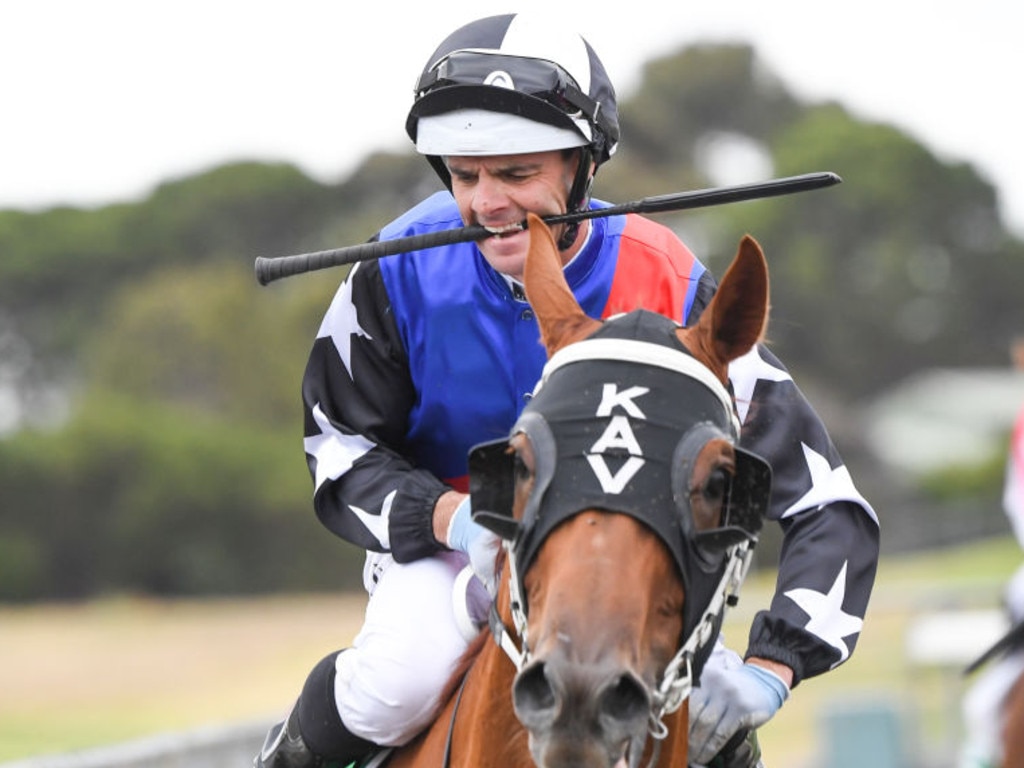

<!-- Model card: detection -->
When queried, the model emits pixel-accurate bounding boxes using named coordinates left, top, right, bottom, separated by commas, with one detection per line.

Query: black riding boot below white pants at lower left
left=253, top=653, right=378, bottom=768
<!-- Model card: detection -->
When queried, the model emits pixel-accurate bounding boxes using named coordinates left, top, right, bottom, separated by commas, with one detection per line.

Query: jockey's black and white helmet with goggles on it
left=406, top=13, right=618, bottom=196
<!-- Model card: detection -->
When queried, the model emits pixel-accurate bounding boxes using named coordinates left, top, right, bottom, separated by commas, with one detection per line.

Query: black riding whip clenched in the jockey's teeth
left=256, top=171, right=843, bottom=286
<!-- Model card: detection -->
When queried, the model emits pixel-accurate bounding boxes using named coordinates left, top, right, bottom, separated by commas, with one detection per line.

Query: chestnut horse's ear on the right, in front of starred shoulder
left=679, top=234, right=768, bottom=382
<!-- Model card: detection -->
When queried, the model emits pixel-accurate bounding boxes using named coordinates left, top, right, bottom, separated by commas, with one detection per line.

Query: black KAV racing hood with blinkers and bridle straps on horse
left=470, top=312, right=770, bottom=760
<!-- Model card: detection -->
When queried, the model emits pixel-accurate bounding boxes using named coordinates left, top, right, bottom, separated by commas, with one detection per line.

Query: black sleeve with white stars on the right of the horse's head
left=729, top=346, right=879, bottom=684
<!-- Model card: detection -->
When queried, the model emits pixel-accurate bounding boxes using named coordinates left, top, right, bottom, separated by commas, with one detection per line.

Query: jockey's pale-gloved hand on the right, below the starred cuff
left=689, top=643, right=790, bottom=765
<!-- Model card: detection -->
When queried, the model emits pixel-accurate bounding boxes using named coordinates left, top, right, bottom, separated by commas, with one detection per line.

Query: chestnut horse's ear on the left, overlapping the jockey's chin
left=523, top=213, right=601, bottom=357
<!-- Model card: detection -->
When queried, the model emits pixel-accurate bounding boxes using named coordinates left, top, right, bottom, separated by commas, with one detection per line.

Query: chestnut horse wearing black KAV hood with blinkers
left=387, top=215, right=770, bottom=768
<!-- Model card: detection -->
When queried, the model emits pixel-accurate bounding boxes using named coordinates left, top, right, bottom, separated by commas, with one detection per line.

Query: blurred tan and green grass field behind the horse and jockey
left=0, top=537, right=1022, bottom=768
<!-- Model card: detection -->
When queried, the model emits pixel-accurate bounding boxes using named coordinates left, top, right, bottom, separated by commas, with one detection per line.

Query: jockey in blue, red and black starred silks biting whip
left=254, top=14, right=879, bottom=768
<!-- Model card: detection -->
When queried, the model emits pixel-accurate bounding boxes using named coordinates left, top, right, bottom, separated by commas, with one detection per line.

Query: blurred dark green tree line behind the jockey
left=0, top=45, right=1024, bottom=600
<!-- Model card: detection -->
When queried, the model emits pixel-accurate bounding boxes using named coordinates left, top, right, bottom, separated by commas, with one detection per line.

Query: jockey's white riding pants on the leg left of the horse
left=334, top=552, right=485, bottom=746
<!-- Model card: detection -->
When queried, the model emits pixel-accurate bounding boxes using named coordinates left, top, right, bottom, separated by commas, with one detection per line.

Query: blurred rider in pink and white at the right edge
left=959, top=337, right=1024, bottom=768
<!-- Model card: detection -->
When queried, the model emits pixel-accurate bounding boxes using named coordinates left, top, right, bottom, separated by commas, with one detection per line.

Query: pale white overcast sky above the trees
left=0, top=0, right=1024, bottom=237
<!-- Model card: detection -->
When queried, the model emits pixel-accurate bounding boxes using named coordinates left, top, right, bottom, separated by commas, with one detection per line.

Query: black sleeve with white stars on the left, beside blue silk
left=302, top=261, right=449, bottom=562
